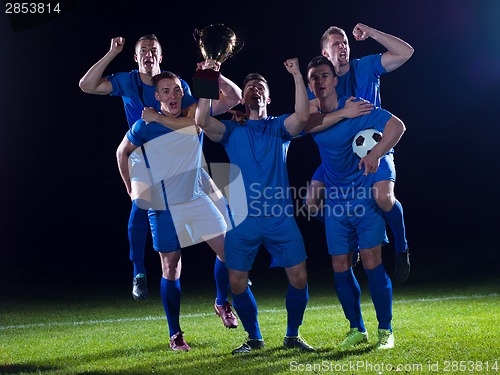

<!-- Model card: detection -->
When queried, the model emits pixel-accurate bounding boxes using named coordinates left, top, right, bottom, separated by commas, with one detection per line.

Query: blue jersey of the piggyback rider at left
left=106, top=70, right=196, bottom=127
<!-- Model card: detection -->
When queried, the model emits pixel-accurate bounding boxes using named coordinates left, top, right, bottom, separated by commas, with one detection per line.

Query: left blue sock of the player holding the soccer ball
left=333, top=268, right=366, bottom=332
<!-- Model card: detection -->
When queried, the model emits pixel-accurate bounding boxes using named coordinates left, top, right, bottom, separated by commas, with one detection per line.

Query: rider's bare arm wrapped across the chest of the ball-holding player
left=304, top=96, right=373, bottom=133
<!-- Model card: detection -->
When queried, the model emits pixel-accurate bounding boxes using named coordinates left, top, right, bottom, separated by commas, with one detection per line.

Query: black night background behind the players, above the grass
left=0, top=0, right=500, bottom=285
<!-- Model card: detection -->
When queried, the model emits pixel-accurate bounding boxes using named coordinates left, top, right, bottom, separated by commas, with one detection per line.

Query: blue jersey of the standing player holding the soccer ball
left=311, top=97, right=392, bottom=201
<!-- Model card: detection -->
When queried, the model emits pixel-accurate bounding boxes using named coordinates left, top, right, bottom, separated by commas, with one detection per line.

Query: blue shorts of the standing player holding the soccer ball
left=325, top=199, right=386, bottom=255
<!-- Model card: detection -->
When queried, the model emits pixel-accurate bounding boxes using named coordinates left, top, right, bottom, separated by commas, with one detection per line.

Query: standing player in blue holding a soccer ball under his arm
left=306, top=56, right=405, bottom=349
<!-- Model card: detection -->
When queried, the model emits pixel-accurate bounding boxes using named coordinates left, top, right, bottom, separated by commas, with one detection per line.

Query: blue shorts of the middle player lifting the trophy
left=224, top=216, right=307, bottom=271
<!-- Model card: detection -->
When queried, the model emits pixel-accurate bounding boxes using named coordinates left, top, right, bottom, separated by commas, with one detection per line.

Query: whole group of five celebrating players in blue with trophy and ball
left=79, top=23, right=413, bottom=355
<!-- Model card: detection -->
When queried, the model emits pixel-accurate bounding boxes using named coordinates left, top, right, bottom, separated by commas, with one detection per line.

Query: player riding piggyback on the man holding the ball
left=306, top=23, right=413, bottom=282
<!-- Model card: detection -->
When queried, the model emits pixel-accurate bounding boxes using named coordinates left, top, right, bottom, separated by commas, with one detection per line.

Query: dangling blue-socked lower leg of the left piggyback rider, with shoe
left=128, top=200, right=149, bottom=300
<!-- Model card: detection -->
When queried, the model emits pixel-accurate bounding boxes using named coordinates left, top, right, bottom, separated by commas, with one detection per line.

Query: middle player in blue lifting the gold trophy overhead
left=196, top=59, right=313, bottom=354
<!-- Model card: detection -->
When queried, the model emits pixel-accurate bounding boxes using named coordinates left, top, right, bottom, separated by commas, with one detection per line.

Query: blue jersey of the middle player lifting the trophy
left=220, top=115, right=293, bottom=216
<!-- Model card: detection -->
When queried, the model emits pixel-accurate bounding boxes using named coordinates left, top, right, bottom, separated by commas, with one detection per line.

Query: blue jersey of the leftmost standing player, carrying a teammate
left=126, top=120, right=205, bottom=206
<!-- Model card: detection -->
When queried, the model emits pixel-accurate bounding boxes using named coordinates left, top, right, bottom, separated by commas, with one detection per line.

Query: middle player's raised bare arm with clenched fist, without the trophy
left=284, top=58, right=309, bottom=136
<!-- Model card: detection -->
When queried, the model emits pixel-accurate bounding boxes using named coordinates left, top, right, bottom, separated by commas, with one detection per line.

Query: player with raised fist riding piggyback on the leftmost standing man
left=80, top=34, right=241, bottom=300
